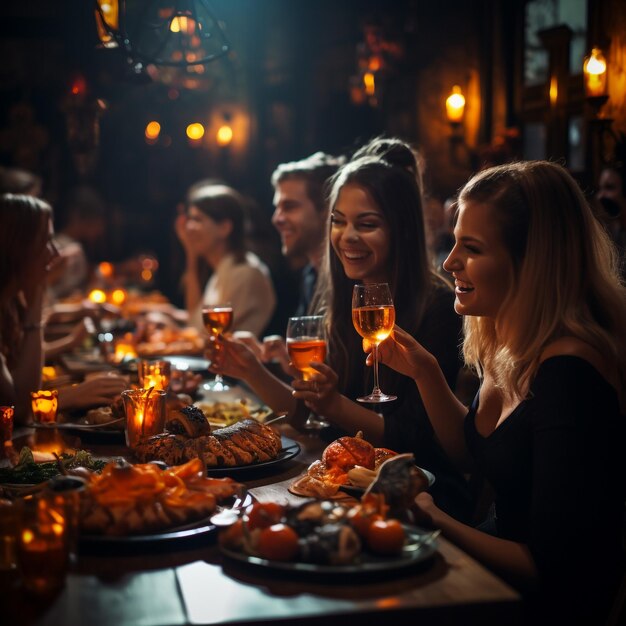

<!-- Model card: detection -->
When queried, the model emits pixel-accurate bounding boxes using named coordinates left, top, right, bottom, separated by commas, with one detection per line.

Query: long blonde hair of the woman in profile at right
left=459, top=161, right=626, bottom=408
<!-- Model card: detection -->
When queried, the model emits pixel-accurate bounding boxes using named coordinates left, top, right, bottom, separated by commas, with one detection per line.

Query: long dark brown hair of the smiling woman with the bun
left=313, top=144, right=438, bottom=389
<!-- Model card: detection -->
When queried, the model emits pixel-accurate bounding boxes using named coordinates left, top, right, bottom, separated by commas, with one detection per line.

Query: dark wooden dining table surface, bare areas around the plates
left=0, top=416, right=521, bottom=626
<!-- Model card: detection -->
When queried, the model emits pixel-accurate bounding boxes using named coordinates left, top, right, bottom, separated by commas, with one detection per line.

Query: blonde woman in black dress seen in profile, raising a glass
left=368, top=162, right=626, bottom=624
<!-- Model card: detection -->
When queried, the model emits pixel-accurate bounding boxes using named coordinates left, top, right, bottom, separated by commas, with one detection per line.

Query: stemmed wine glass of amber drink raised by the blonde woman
left=352, top=283, right=397, bottom=402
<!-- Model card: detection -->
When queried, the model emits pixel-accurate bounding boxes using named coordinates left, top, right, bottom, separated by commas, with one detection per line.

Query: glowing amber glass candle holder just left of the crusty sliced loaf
left=122, top=387, right=167, bottom=448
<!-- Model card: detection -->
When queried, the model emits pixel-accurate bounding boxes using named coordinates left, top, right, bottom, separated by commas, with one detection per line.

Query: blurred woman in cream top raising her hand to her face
left=175, top=184, right=276, bottom=337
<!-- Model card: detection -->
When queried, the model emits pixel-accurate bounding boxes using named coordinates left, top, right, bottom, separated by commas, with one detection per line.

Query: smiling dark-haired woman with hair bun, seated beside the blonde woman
left=207, top=139, right=473, bottom=519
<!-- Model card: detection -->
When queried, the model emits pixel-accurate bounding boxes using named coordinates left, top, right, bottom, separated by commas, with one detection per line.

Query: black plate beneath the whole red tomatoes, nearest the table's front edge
left=220, top=525, right=437, bottom=584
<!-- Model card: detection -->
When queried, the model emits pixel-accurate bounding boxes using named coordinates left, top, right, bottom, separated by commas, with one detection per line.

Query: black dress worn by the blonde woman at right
left=465, top=356, right=626, bottom=626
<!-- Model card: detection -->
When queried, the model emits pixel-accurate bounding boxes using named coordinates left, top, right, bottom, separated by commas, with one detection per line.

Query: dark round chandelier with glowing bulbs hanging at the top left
left=94, top=0, right=230, bottom=72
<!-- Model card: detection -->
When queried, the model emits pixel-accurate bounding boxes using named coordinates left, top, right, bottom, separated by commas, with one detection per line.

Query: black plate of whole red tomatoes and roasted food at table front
left=218, top=494, right=438, bottom=581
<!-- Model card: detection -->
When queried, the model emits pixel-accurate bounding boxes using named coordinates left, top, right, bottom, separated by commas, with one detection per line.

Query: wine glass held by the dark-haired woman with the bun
left=287, top=315, right=330, bottom=429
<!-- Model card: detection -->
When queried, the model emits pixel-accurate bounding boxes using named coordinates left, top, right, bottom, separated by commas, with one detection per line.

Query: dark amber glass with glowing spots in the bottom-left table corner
left=17, top=495, right=69, bottom=594
